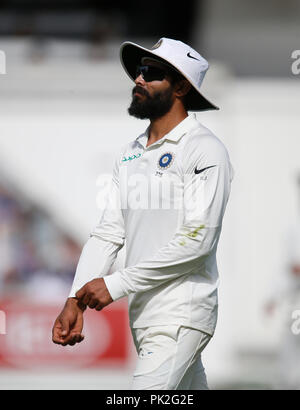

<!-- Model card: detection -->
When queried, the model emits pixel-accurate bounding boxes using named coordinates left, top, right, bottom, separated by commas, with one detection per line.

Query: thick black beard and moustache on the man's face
left=128, top=85, right=173, bottom=120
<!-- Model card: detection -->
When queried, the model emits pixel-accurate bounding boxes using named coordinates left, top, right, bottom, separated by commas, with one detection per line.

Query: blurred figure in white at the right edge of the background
left=265, top=174, right=300, bottom=390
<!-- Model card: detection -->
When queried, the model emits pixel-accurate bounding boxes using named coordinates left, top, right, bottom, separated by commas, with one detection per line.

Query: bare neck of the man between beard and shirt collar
left=147, top=103, right=188, bottom=147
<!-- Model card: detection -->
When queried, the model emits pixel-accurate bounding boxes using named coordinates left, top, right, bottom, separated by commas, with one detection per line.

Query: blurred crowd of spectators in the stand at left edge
left=0, top=181, right=81, bottom=299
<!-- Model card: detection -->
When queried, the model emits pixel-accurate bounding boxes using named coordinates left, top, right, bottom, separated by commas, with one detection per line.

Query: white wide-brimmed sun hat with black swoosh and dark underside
left=120, top=37, right=219, bottom=111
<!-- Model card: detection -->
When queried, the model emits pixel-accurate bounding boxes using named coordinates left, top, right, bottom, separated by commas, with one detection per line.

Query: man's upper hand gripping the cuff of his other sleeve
left=76, top=278, right=113, bottom=310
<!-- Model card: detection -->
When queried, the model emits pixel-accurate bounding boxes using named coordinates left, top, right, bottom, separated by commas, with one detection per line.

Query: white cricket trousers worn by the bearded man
left=132, top=325, right=211, bottom=390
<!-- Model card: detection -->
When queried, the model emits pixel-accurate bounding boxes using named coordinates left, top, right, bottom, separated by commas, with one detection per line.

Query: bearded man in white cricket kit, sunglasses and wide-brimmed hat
left=53, top=38, right=232, bottom=390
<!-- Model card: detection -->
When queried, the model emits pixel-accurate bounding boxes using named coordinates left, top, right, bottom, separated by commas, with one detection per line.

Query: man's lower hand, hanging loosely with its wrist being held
left=52, top=298, right=86, bottom=346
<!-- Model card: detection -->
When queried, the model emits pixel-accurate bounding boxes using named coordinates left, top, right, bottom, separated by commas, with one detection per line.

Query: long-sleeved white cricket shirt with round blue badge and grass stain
left=70, top=114, right=233, bottom=335
